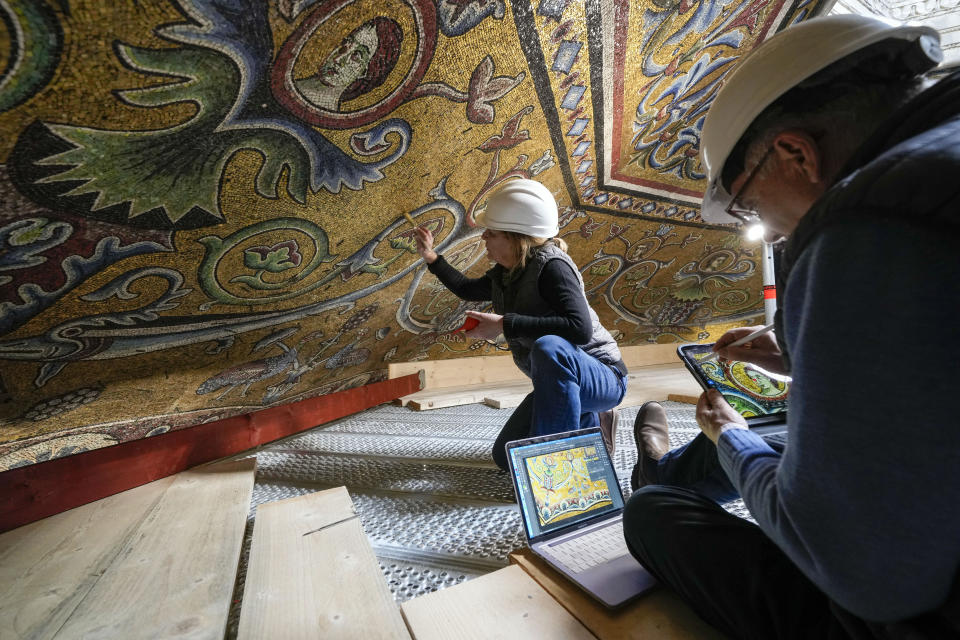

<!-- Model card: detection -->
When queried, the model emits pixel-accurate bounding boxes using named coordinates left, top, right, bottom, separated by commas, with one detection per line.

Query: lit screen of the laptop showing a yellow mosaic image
left=508, top=431, right=623, bottom=538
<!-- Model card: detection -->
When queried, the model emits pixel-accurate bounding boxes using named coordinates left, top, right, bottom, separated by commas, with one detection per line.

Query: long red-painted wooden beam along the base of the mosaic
left=0, top=374, right=421, bottom=532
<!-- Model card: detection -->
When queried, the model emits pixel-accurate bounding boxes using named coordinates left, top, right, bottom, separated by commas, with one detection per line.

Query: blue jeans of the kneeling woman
left=493, top=335, right=627, bottom=470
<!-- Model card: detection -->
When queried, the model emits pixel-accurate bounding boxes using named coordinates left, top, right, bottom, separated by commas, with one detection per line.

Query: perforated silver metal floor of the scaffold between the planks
left=226, top=402, right=746, bottom=639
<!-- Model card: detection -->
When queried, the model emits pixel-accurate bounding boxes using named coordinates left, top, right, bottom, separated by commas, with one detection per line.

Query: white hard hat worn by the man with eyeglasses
left=700, top=14, right=943, bottom=223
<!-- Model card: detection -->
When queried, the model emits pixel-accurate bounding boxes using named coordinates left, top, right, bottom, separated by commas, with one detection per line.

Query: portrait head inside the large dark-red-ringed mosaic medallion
left=294, top=16, right=403, bottom=111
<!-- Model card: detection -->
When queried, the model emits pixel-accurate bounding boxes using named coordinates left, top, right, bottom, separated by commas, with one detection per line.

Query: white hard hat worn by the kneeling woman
left=476, top=178, right=560, bottom=238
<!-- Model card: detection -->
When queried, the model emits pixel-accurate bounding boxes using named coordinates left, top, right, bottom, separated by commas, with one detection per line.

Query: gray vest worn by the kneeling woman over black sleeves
left=487, top=242, right=622, bottom=376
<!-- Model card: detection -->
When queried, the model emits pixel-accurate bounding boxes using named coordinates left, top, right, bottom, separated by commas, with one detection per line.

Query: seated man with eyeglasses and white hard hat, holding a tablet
left=624, top=15, right=960, bottom=638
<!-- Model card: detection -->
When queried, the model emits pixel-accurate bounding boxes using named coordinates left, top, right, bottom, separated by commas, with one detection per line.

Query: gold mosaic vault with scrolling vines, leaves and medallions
left=0, top=0, right=818, bottom=470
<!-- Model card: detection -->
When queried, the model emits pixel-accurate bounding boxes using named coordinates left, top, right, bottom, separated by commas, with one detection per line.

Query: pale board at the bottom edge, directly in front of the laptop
left=401, top=566, right=594, bottom=640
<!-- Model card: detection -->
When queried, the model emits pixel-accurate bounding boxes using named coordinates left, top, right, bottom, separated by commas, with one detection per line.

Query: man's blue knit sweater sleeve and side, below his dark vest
left=718, top=215, right=960, bottom=621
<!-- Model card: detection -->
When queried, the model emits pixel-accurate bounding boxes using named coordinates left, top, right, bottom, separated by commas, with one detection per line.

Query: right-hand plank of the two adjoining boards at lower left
left=57, top=459, right=256, bottom=640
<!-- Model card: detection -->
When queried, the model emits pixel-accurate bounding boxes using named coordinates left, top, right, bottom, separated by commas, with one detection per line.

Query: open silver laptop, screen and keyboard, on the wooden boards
left=507, top=427, right=656, bottom=607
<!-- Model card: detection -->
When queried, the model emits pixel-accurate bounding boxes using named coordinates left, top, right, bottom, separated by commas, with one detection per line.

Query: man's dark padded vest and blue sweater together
left=718, top=73, right=960, bottom=624
